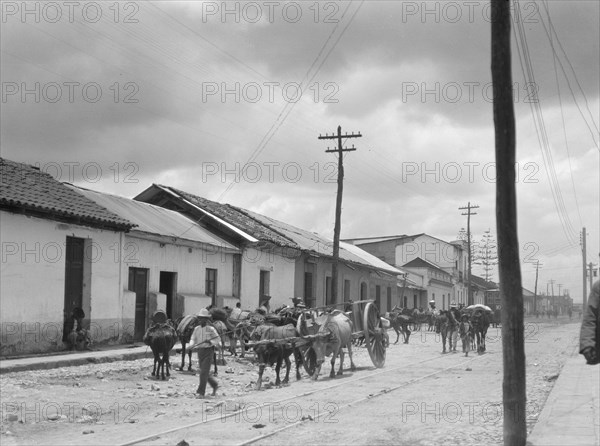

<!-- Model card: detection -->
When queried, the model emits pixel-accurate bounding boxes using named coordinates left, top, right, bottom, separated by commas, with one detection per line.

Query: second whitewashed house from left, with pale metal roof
left=70, top=186, right=240, bottom=340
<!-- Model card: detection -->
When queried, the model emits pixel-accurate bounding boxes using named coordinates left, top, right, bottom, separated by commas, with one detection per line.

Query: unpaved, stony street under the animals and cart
left=1, top=319, right=579, bottom=445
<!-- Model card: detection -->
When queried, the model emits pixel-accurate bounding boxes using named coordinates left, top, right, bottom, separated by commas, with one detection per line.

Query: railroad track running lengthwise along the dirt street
left=121, top=348, right=481, bottom=446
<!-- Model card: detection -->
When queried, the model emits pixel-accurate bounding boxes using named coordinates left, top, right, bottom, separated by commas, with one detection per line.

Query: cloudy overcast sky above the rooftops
left=1, top=0, right=600, bottom=301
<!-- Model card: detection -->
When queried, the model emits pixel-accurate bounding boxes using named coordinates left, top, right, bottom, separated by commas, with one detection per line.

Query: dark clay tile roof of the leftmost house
left=0, top=158, right=136, bottom=231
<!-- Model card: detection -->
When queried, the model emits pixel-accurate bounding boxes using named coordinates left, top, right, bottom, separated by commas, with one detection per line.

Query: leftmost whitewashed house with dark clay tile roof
left=0, top=158, right=134, bottom=356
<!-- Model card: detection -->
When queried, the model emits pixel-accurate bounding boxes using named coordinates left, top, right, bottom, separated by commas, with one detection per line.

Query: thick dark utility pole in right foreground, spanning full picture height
left=491, top=0, right=527, bottom=446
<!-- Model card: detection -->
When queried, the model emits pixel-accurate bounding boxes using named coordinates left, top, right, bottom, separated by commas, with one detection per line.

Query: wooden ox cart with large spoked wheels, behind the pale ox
left=298, top=300, right=388, bottom=376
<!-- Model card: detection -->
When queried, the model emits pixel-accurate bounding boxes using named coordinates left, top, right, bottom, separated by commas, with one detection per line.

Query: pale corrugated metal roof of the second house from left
left=69, top=185, right=239, bottom=251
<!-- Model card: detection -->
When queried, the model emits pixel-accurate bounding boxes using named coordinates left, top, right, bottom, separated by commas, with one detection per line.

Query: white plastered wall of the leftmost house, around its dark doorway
left=0, top=211, right=122, bottom=355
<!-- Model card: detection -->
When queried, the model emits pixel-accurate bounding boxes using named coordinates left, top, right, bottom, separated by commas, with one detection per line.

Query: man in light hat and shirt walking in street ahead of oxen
left=190, top=308, right=221, bottom=398
